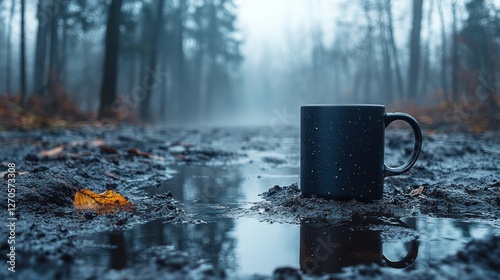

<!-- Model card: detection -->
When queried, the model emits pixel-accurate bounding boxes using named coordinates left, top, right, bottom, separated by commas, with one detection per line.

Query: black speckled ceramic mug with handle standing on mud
left=300, top=105, right=422, bottom=201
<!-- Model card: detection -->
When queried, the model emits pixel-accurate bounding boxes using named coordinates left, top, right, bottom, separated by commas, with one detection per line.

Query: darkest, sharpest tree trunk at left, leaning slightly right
left=99, top=0, right=123, bottom=119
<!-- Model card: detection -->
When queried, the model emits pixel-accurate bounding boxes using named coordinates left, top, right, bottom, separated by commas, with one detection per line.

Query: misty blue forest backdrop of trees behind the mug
left=0, top=0, right=500, bottom=125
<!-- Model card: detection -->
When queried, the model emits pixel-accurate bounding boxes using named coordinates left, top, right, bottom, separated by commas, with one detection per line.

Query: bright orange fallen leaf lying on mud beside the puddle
left=74, top=189, right=135, bottom=215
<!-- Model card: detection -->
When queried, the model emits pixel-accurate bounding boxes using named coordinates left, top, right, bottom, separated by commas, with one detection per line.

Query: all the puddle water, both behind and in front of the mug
left=72, top=162, right=500, bottom=276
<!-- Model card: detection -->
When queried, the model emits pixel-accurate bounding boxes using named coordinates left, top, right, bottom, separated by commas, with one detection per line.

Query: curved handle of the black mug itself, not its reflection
left=384, top=113, right=422, bottom=177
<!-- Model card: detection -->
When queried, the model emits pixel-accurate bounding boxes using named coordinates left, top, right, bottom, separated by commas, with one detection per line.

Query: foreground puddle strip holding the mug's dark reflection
left=77, top=217, right=500, bottom=276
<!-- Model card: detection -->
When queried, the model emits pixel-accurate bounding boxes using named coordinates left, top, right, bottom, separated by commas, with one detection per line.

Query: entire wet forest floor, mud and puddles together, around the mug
left=0, top=126, right=500, bottom=279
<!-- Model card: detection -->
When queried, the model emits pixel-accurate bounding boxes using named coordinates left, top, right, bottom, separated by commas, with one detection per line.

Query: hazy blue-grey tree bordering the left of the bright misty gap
left=190, top=0, right=242, bottom=120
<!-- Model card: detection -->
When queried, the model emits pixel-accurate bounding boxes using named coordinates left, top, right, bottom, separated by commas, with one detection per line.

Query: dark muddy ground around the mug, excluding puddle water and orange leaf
left=0, top=126, right=500, bottom=279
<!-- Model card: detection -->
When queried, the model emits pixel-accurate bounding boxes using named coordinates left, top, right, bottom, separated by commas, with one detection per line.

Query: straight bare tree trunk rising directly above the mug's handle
left=408, top=0, right=423, bottom=103
